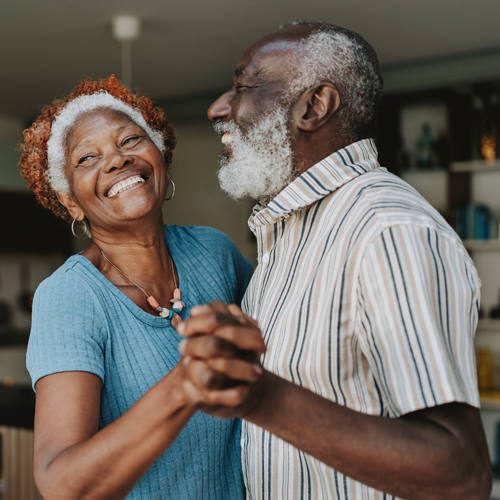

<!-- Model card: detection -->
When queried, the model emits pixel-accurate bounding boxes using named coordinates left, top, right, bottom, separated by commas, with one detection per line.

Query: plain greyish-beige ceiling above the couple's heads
left=0, top=0, right=500, bottom=117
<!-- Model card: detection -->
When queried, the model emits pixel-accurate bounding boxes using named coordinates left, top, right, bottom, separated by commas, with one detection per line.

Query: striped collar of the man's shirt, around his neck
left=248, top=139, right=379, bottom=229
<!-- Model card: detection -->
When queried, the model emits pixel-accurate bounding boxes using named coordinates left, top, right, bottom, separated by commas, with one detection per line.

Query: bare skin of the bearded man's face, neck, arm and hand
left=184, top=26, right=491, bottom=500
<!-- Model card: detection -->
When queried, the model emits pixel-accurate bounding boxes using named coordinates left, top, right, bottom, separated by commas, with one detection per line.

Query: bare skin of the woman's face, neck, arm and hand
left=34, top=110, right=263, bottom=500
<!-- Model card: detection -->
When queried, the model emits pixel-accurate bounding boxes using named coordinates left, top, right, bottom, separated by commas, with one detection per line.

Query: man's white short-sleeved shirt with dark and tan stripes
left=242, top=140, right=480, bottom=500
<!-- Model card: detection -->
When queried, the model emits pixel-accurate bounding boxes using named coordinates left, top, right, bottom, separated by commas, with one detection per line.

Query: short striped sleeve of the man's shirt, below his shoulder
left=356, top=225, right=480, bottom=417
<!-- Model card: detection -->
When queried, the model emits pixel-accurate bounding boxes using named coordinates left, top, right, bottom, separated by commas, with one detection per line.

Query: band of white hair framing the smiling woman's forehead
left=47, top=91, right=165, bottom=194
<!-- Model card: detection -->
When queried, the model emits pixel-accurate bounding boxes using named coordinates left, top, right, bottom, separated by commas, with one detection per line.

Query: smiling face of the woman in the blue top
left=62, top=109, right=170, bottom=230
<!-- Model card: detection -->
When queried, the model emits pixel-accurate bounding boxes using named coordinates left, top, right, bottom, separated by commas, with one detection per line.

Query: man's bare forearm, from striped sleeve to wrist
left=244, top=372, right=491, bottom=500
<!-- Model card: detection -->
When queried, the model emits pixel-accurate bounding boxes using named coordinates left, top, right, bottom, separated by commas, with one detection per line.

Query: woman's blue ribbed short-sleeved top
left=27, top=226, right=252, bottom=500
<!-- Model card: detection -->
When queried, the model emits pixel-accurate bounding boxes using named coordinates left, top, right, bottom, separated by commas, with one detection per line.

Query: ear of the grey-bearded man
left=292, top=82, right=340, bottom=132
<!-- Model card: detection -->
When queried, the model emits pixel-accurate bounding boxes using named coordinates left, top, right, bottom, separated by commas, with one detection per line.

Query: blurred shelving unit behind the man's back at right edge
left=377, top=84, right=500, bottom=499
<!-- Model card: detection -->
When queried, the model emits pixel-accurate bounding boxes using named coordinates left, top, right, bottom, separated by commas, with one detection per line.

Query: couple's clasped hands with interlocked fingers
left=177, top=302, right=266, bottom=418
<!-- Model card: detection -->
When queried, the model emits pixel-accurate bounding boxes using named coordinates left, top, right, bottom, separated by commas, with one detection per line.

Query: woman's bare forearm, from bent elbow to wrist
left=35, top=366, right=196, bottom=500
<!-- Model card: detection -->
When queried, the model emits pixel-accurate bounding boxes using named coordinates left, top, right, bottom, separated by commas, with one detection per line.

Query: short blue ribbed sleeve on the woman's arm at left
left=26, top=269, right=105, bottom=389
